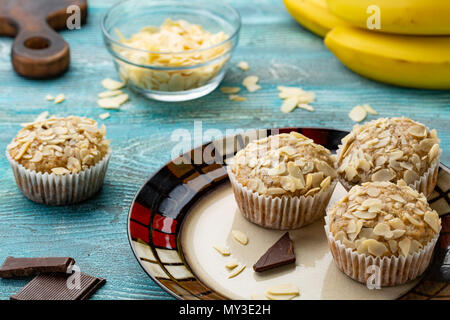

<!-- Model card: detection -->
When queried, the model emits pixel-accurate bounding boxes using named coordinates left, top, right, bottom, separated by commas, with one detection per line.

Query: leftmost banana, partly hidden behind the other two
left=283, top=0, right=352, bottom=37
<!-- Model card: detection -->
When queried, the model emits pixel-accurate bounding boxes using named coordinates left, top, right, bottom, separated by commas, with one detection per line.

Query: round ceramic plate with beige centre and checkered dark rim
left=128, top=128, right=450, bottom=300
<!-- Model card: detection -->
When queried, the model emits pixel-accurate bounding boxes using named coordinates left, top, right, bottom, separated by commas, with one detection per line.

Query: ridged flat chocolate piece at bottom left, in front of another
left=10, top=272, right=106, bottom=300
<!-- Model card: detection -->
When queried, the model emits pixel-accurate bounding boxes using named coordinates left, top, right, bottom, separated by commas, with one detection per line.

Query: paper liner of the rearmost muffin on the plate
left=337, top=145, right=442, bottom=198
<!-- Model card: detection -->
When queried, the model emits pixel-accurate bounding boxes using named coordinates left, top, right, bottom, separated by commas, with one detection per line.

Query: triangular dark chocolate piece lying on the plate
left=253, top=232, right=295, bottom=272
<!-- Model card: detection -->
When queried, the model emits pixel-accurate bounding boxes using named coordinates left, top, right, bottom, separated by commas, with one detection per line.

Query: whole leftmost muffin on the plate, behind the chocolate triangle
left=227, top=132, right=337, bottom=229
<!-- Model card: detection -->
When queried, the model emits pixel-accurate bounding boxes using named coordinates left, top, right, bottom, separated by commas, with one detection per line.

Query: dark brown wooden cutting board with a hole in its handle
left=0, top=0, right=87, bottom=79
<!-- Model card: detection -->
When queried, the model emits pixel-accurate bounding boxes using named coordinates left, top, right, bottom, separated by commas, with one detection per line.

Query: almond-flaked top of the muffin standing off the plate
left=7, top=116, right=109, bottom=174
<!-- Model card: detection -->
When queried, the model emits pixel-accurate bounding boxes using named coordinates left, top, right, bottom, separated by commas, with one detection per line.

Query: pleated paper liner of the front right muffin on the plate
left=325, top=216, right=439, bottom=287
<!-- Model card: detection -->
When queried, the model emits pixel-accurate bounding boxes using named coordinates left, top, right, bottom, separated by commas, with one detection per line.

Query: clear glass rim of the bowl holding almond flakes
left=100, top=0, right=242, bottom=55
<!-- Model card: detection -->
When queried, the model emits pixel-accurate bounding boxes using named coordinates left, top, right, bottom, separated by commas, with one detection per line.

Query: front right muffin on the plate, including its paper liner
left=325, top=180, right=441, bottom=286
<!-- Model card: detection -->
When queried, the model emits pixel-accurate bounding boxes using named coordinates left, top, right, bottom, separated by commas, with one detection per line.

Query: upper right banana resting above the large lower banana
left=327, top=0, right=450, bottom=35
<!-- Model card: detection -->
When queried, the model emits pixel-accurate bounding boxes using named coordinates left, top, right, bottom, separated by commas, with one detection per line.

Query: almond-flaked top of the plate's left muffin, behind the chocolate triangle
left=231, top=132, right=337, bottom=197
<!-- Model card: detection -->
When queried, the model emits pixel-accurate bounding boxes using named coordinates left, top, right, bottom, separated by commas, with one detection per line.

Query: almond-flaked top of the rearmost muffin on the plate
left=337, top=117, right=440, bottom=185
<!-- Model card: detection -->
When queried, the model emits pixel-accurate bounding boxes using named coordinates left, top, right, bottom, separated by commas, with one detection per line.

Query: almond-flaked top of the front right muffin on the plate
left=327, top=180, right=441, bottom=257
